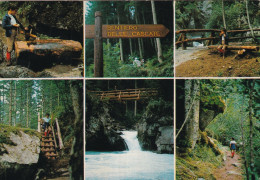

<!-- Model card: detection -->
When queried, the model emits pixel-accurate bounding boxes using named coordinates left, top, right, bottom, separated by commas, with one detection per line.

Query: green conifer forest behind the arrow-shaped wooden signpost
left=85, top=1, right=173, bottom=77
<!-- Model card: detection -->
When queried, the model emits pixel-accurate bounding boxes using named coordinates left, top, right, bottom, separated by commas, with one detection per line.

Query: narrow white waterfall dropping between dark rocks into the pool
left=121, top=131, right=141, bottom=151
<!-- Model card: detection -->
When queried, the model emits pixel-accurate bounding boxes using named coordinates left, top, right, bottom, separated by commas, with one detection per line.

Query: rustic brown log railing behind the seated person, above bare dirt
left=175, top=29, right=260, bottom=50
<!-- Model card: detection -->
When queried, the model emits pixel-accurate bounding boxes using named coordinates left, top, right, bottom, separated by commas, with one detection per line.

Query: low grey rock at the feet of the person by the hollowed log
left=0, top=66, right=35, bottom=78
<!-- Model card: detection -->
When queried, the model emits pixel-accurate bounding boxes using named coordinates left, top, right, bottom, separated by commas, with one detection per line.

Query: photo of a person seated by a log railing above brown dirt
left=175, top=0, right=260, bottom=77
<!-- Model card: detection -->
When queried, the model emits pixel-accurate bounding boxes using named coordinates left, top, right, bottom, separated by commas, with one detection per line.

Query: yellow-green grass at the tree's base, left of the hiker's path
left=176, top=144, right=222, bottom=179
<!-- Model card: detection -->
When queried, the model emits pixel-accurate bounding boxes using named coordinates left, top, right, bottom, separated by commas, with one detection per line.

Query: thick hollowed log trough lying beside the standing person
left=15, top=39, right=82, bottom=59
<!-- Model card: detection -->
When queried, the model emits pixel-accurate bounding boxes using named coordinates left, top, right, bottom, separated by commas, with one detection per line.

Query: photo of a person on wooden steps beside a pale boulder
left=0, top=80, right=83, bottom=180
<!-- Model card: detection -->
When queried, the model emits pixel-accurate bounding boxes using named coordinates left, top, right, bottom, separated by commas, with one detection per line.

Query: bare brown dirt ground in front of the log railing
left=175, top=49, right=260, bottom=77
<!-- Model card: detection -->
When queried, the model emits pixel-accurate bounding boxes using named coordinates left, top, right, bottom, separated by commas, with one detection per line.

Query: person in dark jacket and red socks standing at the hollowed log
left=2, top=5, right=28, bottom=66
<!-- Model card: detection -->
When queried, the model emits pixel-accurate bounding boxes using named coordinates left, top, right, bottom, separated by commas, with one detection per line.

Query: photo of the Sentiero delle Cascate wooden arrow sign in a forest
left=85, top=1, right=173, bottom=77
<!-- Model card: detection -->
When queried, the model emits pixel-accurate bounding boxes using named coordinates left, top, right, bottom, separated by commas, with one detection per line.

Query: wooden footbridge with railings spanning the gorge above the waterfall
left=89, top=88, right=158, bottom=101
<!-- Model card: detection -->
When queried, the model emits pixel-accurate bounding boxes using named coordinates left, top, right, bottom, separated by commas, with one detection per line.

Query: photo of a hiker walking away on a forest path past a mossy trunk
left=175, top=79, right=260, bottom=180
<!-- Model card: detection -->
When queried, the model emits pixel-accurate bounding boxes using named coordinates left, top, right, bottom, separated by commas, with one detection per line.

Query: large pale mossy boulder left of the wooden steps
left=0, top=131, right=40, bottom=180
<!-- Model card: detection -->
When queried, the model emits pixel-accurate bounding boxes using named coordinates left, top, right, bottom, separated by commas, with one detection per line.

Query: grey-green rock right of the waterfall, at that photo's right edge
left=155, top=126, right=173, bottom=153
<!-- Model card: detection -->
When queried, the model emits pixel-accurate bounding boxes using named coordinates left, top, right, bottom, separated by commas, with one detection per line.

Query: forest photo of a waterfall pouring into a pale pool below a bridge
left=85, top=79, right=174, bottom=180
